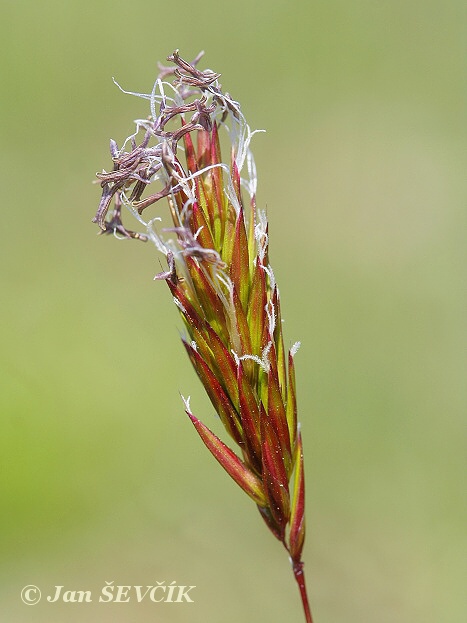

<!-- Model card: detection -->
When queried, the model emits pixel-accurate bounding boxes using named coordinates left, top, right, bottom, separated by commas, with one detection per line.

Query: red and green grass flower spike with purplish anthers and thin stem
left=94, top=51, right=311, bottom=621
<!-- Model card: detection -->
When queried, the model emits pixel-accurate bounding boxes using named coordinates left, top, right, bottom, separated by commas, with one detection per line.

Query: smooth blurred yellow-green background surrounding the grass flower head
left=0, top=0, right=467, bottom=623
